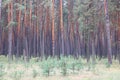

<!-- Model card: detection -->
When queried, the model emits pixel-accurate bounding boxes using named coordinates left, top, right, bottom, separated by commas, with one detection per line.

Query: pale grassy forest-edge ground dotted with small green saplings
left=0, top=56, right=120, bottom=80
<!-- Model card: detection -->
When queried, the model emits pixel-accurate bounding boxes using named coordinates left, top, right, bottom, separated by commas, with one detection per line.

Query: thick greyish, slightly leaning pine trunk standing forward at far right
left=104, top=0, right=112, bottom=64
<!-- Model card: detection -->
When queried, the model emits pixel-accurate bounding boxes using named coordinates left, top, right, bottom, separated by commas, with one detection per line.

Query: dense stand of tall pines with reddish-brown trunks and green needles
left=0, top=0, right=120, bottom=63
